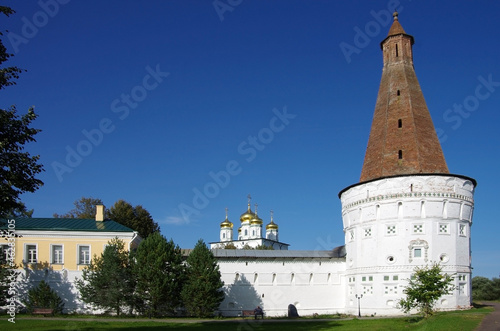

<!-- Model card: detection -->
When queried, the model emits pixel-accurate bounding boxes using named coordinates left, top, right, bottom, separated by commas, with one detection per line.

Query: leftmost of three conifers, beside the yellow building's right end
left=75, top=238, right=135, bottom=315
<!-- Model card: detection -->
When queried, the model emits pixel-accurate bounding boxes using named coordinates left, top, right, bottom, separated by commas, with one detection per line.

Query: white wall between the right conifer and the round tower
left=218, top=258, right=345, bottom=316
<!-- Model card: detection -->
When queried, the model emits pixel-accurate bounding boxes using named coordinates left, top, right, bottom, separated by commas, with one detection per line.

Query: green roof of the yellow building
left=0, top=217, right=134, bottom=232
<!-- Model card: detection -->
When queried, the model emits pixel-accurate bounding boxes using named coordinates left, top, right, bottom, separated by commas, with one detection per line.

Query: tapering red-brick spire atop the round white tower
left=360, top=12, right=449, bottom=182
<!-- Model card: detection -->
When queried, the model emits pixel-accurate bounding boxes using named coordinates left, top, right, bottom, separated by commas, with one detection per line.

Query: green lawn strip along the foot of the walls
left=0, top=306, right=492, bottom=331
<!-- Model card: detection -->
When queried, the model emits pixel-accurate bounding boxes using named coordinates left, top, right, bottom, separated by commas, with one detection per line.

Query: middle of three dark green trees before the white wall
left=133, top=232, right=184, bottom=317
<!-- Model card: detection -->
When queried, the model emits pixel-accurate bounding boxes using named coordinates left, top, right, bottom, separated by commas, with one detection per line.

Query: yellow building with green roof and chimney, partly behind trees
left=0, top=206, right=142, bottom=312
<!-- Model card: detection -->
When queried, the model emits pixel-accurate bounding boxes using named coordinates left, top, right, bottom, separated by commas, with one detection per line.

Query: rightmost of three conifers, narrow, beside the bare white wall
left=181, top=239, right=224, bottom=317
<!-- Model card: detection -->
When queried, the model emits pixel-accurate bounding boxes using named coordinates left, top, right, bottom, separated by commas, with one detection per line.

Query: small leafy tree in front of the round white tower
left=398, top=263, right=455, bottom=318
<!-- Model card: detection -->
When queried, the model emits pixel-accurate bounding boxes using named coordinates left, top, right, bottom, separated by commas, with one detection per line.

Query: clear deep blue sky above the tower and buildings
left=0, top=0, right=500, bottom=277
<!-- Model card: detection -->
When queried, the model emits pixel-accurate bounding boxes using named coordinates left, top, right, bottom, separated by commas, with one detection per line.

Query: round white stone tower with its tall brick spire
left=339, top=13, right=476, bottom=315
